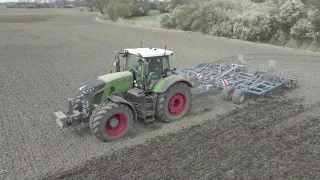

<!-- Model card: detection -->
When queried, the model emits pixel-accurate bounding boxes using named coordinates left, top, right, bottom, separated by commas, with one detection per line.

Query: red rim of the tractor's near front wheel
left=105, top=114, right=127, bottom=136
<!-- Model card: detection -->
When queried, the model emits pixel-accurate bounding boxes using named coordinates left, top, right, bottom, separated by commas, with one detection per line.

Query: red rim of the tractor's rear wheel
left=168, top=93, right=186, bottom=116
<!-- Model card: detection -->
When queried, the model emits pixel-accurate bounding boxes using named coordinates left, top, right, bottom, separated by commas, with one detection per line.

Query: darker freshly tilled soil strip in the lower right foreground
left=44, top=96, right=320, bottom=179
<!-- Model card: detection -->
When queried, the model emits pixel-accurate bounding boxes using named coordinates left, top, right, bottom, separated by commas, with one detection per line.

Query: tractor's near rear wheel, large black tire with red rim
left=155, top=82, right=193, bottom=123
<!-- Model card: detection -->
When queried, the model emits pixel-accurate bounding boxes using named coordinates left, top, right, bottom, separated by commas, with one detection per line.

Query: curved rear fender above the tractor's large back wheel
left=153, top=74, right=193, bottom=93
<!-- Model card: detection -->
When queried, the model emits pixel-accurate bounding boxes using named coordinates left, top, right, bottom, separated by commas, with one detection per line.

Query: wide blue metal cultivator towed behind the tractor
left=177, top=56, right=297, bottom=104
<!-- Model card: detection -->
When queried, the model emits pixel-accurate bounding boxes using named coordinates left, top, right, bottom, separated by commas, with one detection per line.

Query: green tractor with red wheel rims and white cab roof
left=54, top=46, right=193, bottom=142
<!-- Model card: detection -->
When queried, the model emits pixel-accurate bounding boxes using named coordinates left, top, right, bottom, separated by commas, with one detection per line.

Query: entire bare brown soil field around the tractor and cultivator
left=0, top=8, right=320, bottom=180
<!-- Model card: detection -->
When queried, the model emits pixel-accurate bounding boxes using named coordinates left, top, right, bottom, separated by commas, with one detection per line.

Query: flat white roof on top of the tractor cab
left=124, top=48, right=173, bottom=58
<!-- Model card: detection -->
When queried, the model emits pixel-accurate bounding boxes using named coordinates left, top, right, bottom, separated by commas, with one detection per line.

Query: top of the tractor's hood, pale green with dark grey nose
left=79, top=71, right=133, bottom=94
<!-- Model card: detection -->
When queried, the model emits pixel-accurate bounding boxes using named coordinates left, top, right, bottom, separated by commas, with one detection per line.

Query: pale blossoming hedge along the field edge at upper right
left=158, top=0, right=320, bottom=47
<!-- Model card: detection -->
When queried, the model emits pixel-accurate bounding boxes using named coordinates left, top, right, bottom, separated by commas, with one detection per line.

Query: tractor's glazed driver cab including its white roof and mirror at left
left=115, top=48, right=173, bottom=91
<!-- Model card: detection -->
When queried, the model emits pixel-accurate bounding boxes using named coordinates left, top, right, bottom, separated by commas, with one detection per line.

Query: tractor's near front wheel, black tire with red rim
left=90, top=102, right=134, bottom=142
